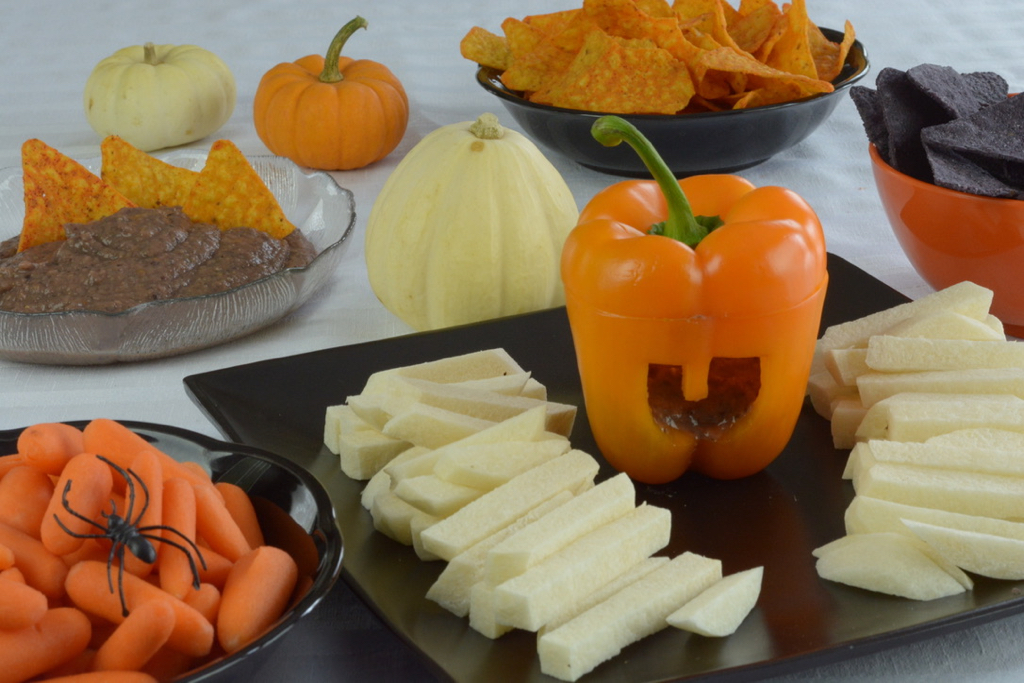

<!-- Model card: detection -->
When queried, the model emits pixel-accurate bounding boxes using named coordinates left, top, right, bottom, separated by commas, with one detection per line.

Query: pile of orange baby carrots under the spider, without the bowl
left=0, top=419, right=301, bottom=683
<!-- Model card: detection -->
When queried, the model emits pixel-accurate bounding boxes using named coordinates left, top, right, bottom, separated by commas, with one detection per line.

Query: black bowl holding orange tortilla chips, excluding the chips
left=476, top=28, right=868, bottom=177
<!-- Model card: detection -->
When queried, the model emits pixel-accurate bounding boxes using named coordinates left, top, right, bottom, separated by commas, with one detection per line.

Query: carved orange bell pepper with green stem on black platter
left=561, top=117, right=828, bottom=483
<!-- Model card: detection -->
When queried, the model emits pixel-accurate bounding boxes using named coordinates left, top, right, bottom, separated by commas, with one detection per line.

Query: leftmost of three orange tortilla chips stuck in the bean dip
left=17, top=139, right=134, bottom=252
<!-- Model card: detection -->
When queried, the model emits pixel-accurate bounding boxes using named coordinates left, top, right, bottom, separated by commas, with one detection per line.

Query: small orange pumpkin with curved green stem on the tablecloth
left=253, top=16, right=409, bottom=171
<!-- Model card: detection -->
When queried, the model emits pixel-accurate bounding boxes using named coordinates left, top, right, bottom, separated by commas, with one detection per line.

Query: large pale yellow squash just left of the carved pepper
left=366, top=114, right=579, bottom=330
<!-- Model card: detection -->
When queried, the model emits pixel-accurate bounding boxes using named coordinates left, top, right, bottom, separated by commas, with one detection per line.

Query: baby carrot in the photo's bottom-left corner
left=0, top=607, right=92, bottom=683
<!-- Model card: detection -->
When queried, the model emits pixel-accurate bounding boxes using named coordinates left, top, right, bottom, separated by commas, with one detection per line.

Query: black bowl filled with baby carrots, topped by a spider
left=0, top=419, right=343, bottom=681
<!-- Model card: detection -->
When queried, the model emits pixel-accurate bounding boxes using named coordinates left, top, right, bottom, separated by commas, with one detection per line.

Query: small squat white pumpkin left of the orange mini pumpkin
left=84, top=43, right=237, bottom=152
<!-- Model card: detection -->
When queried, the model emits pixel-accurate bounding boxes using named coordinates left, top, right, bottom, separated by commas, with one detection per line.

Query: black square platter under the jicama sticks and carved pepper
left=185, top=255, right=1024, bottom=683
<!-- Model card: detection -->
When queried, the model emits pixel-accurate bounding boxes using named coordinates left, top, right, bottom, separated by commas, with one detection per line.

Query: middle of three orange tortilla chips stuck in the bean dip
left=99, top=135, right=199, bottom=209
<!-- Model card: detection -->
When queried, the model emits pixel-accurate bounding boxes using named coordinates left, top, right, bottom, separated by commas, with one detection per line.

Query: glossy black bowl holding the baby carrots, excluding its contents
left=0, top=421, right=343, bottom=683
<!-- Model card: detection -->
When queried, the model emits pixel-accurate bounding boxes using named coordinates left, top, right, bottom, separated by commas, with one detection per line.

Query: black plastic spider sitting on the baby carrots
left=53, top=456, right=206, bottom=616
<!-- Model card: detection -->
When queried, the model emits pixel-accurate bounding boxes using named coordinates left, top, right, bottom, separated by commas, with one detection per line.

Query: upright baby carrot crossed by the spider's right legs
left=157, top=477, right=205, bottom=598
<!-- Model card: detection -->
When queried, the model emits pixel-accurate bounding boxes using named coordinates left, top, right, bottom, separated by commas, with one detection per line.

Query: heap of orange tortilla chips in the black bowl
left=464, top=0, right=853, bottom=114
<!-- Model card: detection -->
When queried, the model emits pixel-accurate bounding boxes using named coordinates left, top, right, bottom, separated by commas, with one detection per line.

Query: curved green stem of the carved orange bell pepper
left=591, top=116, right=709, bottom=247
